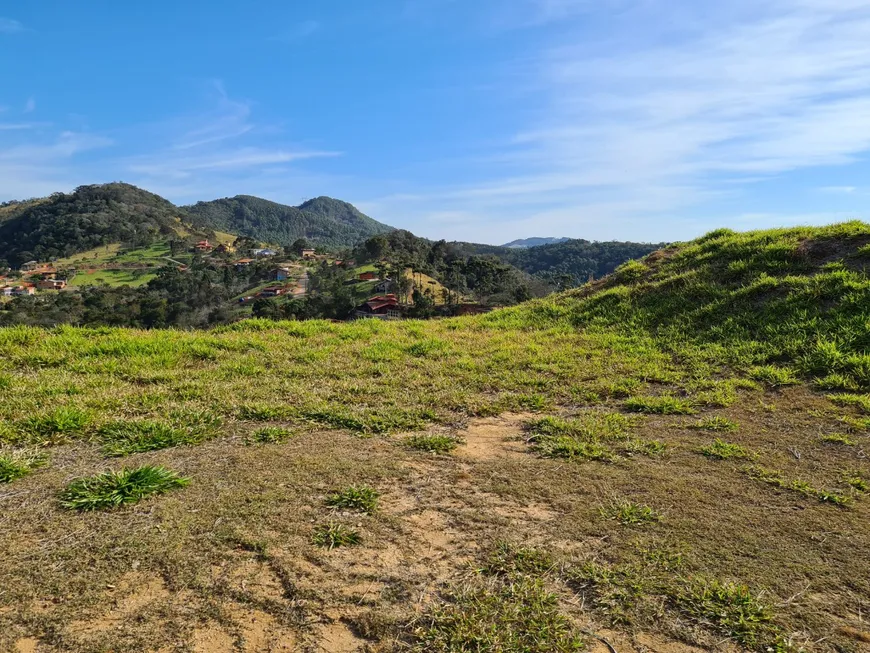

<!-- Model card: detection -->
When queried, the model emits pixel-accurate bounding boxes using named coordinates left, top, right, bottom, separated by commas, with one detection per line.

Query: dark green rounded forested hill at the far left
left=0, top=183, right=194, bottom=267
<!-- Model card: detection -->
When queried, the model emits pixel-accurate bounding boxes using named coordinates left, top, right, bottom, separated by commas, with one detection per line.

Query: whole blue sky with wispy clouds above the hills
left=0, top=0, right=870, bottom=243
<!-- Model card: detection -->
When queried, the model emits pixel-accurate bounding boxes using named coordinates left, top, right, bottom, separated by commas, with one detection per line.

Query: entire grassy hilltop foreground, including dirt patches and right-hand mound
left=0, top=222, right=870, bottom=653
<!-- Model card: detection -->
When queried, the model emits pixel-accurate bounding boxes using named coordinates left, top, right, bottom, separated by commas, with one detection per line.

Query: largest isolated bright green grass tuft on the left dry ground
left=60, top=465, right=190, bottom=511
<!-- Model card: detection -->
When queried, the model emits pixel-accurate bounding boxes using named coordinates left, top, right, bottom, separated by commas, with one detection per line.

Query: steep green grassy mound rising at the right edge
left=510, top=221, right=870, bottom=390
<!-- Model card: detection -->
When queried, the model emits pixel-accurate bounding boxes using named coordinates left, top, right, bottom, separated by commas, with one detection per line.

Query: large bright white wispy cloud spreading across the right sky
left=372, top=0, right=870, bottom=241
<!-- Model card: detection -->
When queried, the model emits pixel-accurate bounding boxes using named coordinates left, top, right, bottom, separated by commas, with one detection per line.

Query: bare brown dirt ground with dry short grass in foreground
left=0, top=388, right=870, bottom=653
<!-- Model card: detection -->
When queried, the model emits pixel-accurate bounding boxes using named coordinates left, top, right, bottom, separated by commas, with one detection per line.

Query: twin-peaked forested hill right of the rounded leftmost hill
left=185, top=195, right=393, bottom=248
